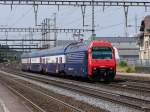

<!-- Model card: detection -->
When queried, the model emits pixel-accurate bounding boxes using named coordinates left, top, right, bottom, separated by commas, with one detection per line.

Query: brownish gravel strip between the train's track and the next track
left=13, top=70, right=150, bottom=100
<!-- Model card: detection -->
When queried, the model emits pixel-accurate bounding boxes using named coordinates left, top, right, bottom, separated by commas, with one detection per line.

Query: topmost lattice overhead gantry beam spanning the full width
left=0, top=0, right=150, bottom=7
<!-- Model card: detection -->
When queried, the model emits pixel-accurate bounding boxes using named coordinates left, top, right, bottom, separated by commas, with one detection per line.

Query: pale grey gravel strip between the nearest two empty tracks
left=0, top=71, right=142, bottom=112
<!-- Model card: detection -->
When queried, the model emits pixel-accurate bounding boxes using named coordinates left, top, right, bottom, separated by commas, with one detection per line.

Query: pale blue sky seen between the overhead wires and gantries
left=0, top=0, right=150, bottom=44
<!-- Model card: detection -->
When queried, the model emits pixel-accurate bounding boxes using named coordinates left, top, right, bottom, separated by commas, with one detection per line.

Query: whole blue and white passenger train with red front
left=21, top=40, right=116, bottom=81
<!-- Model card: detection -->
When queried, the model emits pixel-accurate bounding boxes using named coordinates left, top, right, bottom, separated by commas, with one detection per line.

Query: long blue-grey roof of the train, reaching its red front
left=22, top=41, right=110, bottom=58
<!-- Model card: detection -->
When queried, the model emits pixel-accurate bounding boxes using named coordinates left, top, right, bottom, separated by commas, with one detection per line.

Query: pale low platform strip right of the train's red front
left=116, top=72, right=150, bottom=81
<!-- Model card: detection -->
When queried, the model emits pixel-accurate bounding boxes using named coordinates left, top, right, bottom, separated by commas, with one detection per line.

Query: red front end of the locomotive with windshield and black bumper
left=88, top=41, right=116, bottom=81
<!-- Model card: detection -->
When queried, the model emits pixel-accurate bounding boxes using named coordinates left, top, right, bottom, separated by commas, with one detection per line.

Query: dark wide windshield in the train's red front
left=92, top=46, right=112, bottom=59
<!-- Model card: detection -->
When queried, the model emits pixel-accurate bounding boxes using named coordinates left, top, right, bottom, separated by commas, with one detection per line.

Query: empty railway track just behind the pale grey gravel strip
left=1, top=71, right=150, bottom=112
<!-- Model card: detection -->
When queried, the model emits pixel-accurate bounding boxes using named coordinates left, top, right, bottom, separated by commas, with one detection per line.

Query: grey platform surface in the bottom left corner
left=0, top=83, right=31, bottom=112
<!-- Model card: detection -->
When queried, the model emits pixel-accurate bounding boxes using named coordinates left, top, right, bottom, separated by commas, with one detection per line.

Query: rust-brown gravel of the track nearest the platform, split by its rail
left=1, top=71, right=106, bottom=112
